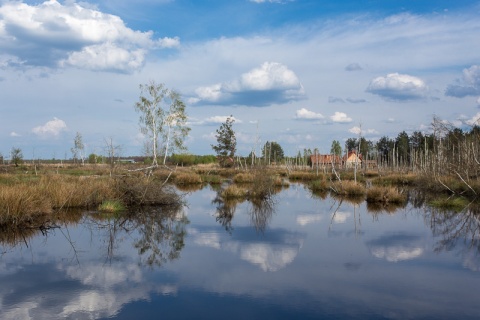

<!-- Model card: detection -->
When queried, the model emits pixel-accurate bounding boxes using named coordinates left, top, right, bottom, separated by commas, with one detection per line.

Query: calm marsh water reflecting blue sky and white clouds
left=0, top=184, right=480, bottom=319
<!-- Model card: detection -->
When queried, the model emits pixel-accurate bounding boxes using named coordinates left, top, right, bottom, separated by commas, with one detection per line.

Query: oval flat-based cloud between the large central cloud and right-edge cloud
left=366, top=73, right=428, bottom=101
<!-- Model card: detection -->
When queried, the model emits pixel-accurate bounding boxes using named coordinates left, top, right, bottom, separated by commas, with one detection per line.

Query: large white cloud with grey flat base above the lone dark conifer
left=190, top=62, right=305, bottom=107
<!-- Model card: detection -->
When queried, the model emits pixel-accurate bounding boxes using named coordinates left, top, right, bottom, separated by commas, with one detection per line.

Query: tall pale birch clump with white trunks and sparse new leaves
left=135, top=81, right=190, bottom=166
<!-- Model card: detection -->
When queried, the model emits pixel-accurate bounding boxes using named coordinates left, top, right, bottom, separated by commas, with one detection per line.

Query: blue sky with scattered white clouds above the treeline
left=0, top=0, right=480, bottom=159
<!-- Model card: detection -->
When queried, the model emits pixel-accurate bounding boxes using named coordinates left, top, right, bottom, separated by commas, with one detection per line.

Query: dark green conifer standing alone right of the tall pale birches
left=212, top=115, right=237, bottom=167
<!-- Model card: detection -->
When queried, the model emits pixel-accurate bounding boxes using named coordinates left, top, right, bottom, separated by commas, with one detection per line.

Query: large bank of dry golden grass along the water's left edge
left=0, top=175, right=182, bottom=226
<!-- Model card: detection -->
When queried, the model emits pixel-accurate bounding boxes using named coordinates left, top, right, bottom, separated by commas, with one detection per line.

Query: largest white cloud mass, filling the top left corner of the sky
left=0, top=0, right=179, bottom=72
